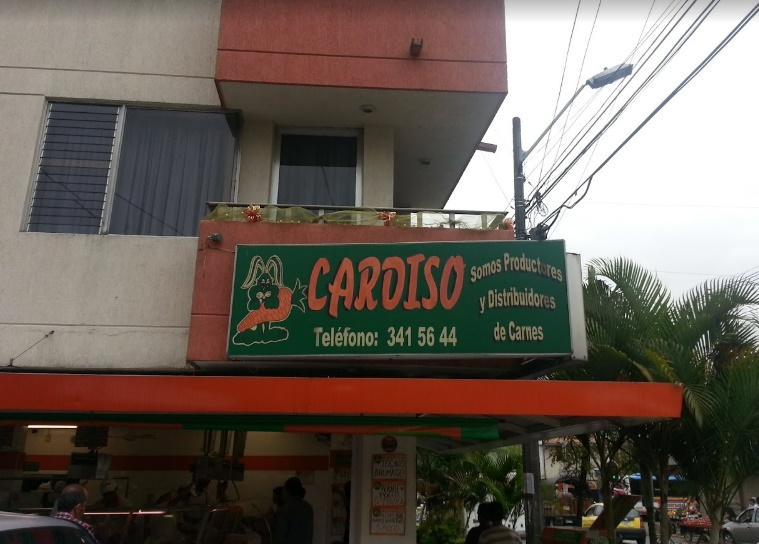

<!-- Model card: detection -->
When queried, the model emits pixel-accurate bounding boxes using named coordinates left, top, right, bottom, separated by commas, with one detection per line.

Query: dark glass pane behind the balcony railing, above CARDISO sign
left=277, top=134, right=358, bottom=206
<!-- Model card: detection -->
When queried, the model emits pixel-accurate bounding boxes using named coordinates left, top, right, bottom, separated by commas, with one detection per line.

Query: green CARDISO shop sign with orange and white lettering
left=227, top=241, right=572, bottom=359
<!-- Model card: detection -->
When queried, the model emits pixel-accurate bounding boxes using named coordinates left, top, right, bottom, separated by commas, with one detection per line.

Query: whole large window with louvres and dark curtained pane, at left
left=28, top=102, right=238, bottom=236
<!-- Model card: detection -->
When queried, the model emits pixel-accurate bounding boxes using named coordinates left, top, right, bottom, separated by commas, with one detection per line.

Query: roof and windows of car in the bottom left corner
left=0, top=512, right=97, bottom=544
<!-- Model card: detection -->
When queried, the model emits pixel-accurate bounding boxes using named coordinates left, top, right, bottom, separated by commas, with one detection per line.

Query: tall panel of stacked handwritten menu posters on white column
left=369, top=453, right=406, bottom=536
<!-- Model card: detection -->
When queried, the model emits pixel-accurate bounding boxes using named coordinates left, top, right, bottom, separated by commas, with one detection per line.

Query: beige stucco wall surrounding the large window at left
left=0, top=0, right=221, bottom=368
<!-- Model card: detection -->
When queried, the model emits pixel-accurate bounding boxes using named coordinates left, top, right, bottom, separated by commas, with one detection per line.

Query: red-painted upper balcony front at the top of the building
left=216, top=0, right=506, bottom=94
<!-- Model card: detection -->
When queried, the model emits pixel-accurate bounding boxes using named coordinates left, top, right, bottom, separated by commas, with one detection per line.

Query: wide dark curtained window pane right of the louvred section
left=109, top=108, right=237, bottom=236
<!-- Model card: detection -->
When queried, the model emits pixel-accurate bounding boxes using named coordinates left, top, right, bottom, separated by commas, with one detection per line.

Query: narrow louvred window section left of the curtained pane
left=29, top=103, right=120, bottom=234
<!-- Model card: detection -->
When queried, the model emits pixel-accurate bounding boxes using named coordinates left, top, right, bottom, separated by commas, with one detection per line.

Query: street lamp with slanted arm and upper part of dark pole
left=512, top=64, right=633, bottom=240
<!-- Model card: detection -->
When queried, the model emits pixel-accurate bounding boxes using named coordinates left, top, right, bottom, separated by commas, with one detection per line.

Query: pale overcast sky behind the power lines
left=447, top=0, right=759, bottom=295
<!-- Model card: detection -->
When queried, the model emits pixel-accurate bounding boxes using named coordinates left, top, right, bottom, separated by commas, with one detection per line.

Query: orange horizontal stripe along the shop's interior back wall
left=22, top=454, right=329, bottom=472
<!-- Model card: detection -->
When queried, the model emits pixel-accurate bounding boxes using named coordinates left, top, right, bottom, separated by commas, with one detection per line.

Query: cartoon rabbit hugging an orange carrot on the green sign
left=232, top=255, right=307, bottom=346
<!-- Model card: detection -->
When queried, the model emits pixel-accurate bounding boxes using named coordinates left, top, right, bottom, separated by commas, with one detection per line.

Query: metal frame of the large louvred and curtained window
left=25, top=98, right=243, bottom=238
